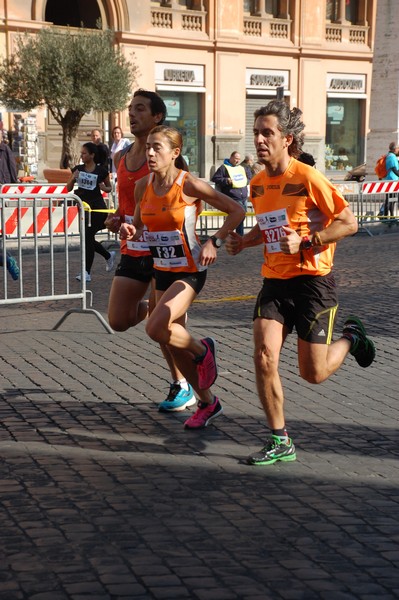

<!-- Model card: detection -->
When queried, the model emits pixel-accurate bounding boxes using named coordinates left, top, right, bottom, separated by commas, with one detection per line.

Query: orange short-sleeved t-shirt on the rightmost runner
left=250, top=158, right=348, bottom=279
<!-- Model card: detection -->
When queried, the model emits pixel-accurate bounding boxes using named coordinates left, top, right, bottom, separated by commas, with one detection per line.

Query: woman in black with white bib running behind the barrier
left=66, top=142, right=115, bottom=282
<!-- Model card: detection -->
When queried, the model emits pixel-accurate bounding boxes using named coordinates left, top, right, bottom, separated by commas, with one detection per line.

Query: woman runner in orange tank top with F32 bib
left=120, top=125, right=244, bottom=429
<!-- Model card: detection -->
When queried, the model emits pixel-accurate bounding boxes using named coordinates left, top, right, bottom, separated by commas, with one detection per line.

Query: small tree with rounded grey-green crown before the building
left=0, top=27, right=137, bottom=168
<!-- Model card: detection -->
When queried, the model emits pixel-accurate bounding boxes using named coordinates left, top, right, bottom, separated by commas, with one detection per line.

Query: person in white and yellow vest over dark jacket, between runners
left=212, top=151, right=252, bottom=235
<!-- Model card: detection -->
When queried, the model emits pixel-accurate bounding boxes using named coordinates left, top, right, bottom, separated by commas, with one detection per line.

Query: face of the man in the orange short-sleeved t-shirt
left=254, top=115, right=291, bottom=164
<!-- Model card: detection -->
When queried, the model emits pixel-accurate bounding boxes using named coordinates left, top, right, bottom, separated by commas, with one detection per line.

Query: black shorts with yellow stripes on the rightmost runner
left=254, top=273, right=338, bottom=344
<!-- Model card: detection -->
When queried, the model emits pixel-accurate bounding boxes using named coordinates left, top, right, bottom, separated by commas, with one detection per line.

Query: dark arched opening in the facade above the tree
left=45, top=0, right=103, bottom=29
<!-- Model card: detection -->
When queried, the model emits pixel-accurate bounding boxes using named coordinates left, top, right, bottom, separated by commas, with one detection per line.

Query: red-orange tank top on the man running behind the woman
left=118, top=146, right=151, bottom=256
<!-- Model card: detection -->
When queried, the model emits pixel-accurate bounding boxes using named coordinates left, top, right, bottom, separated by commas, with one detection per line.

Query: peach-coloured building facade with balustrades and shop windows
left=0, top=0, right=377, bottom=178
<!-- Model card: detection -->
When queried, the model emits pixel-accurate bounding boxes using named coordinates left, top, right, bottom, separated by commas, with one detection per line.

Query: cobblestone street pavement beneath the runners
left=0, top=233, right=399, bottom=600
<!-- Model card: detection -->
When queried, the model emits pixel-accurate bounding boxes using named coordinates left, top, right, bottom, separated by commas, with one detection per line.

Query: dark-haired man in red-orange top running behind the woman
left=105, top=89, right=196, bottom=412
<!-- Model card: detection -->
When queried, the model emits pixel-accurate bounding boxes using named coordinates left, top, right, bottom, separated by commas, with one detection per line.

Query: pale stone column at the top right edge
left=366, top=0, right=399, bottom=180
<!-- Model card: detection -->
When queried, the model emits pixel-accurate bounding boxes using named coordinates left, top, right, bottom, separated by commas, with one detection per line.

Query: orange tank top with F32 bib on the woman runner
left=140, top=171, right=206, bottom=273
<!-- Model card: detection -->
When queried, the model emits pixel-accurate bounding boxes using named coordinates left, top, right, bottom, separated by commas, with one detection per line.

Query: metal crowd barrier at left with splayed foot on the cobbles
left=0, top=188, right=113, bottom=333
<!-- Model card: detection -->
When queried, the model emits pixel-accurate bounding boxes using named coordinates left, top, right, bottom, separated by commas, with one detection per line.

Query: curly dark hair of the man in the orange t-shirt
left=254, top=100, right=305, bottom=158
